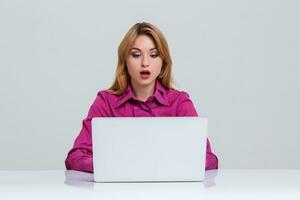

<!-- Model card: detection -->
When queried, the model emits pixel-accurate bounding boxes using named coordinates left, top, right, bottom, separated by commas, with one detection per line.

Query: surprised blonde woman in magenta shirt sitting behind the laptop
left=65, top=22, right=218, bottom=172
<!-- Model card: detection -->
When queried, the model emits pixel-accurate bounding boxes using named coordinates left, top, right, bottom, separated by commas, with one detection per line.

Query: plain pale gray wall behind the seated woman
left=0, top=0, right=300, bottom=169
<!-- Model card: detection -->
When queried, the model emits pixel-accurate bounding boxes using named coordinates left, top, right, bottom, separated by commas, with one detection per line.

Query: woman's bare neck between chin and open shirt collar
left=131, top=81, right=155, bottom=101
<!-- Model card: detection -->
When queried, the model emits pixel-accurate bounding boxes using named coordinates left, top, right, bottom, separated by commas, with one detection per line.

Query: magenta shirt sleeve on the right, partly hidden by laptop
left=177, top=92, right=218, bottom=170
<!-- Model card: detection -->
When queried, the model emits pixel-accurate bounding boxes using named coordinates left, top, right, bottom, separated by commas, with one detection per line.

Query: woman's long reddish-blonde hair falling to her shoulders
left=107, top=22, right=173, bottom=95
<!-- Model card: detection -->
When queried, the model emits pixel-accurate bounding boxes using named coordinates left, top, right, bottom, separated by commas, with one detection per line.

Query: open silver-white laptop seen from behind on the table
left=92, top=117, right=207, bottom=182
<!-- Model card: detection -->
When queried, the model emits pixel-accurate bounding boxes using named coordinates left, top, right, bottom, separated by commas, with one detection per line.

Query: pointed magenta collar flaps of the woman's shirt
left=116, top=80, right=169, bottom=108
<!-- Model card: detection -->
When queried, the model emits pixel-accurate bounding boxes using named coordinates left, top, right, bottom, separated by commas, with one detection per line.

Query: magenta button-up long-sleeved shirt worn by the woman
left=65, top=81, right=218, bottom=173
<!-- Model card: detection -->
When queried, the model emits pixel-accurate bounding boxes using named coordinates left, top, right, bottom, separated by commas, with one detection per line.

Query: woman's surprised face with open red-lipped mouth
left=126, top=35, right=163, bottom=87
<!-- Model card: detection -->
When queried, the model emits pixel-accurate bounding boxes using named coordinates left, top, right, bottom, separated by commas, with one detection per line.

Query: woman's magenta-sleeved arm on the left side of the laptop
left=65, top=92, right=109, bottom=173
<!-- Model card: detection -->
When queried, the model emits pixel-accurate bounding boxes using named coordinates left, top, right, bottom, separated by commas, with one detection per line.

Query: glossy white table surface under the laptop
left=0, top=169, right=300, bottom=200
